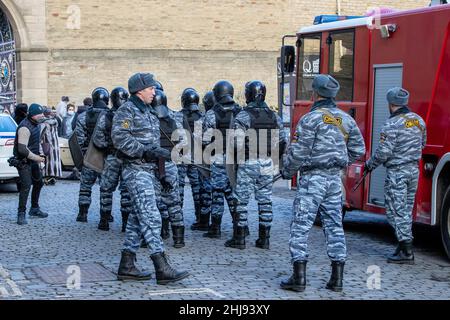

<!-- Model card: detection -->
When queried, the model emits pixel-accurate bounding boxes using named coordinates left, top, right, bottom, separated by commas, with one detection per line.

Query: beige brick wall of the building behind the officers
left=46, top=0, right=429, bottom=108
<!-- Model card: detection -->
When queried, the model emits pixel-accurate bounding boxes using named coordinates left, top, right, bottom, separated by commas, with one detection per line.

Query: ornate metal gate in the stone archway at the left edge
left=0, top=9, right=17, bottom=112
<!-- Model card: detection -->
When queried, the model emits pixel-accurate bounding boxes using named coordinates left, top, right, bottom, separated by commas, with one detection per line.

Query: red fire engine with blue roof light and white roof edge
left=281, top=5, right=450, bottom=257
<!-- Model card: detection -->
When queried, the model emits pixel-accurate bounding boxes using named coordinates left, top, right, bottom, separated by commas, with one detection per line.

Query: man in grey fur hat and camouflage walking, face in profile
left=111, top=73, right=189, bottom=284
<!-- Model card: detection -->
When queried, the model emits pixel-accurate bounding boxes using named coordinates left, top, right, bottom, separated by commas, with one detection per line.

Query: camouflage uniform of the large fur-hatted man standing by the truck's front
left=284, top=99, right=365, bottom=263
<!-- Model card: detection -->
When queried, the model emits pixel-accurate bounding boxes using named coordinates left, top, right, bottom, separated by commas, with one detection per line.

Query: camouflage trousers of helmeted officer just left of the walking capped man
left=100, top=154, right=131, bottom=217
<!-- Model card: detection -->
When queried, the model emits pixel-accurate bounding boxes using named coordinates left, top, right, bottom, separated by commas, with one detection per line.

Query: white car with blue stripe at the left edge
left=0, top=114, right=19, bottom=183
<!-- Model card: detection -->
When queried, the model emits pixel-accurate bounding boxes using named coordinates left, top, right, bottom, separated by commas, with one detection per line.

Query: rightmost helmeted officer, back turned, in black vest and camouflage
left=225, top=81, right=288, bottom=249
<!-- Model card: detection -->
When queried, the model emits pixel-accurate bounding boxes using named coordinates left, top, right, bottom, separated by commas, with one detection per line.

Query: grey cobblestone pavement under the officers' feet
left=0, top=175, right=450, bottom=300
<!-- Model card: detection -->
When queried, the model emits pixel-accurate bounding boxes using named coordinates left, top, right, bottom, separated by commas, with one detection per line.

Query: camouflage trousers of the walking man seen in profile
left=122, top=164, right=164, bottom=254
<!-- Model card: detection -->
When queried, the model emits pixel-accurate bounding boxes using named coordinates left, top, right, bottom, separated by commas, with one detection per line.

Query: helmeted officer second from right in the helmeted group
left=203, top=81, right=241, bottom=238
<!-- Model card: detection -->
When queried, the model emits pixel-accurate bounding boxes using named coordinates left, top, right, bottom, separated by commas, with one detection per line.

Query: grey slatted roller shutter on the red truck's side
left=368, top=64, right=403, bottom=207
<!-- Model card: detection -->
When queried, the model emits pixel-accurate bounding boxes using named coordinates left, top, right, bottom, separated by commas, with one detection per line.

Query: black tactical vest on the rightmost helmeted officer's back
left=245, top=107, right=278, bottom=160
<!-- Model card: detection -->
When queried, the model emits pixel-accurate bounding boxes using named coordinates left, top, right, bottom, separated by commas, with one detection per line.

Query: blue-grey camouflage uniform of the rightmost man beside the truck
left=366, top=107, right=426, bottom=242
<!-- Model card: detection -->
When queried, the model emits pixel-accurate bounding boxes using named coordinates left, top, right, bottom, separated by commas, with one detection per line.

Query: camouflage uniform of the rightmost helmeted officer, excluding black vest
left=233, top=103, right=288, bottom=227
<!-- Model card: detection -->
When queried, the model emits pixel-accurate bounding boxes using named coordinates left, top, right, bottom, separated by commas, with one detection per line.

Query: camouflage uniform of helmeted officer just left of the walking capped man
left=92, top=110, right=132, bottom=231
